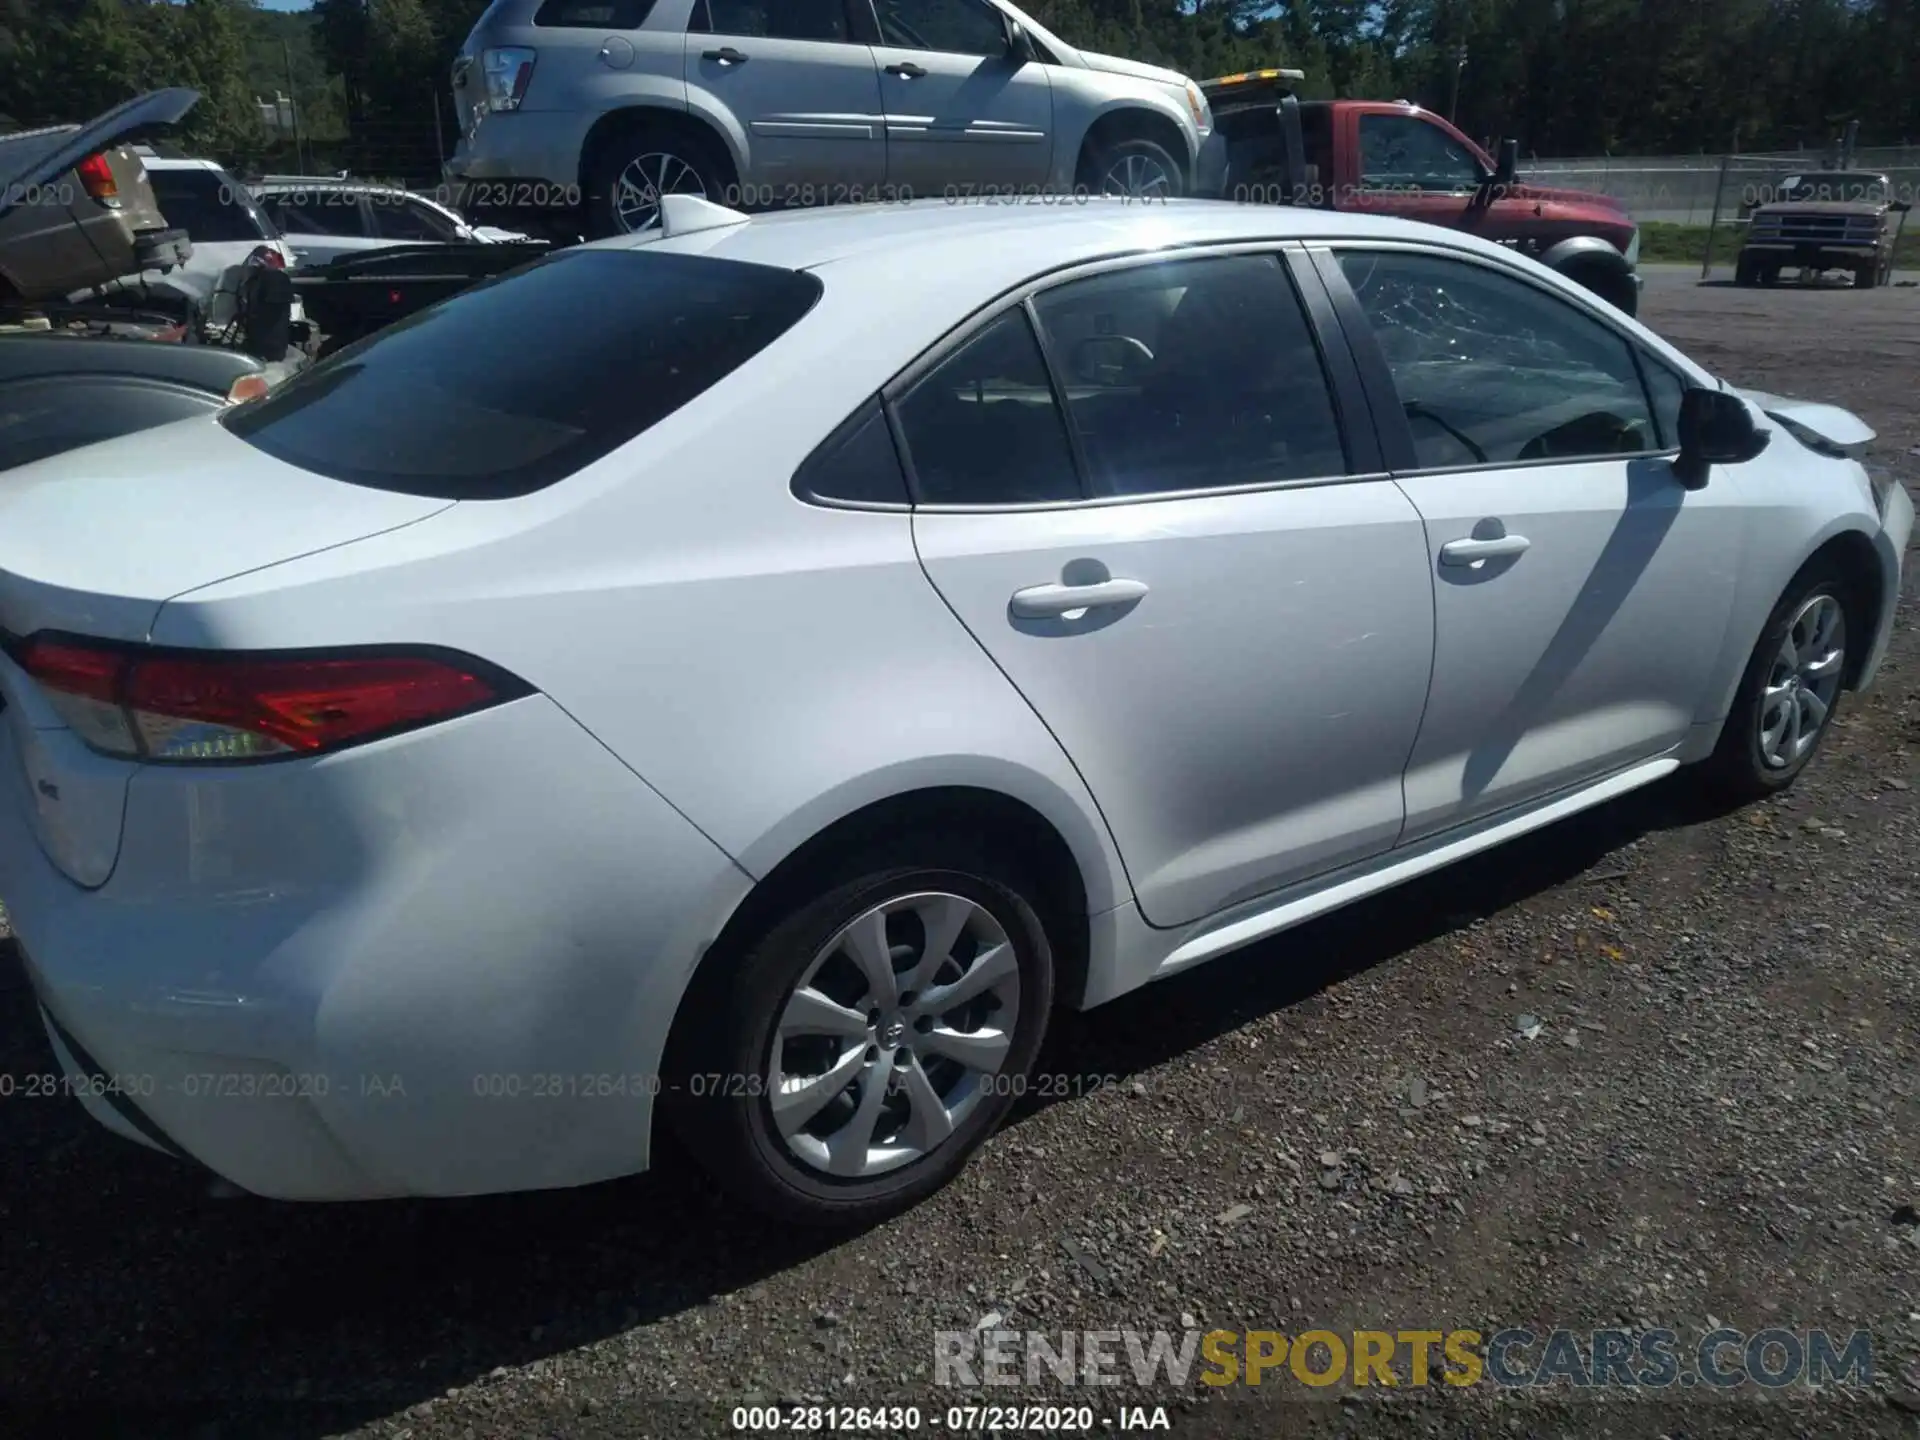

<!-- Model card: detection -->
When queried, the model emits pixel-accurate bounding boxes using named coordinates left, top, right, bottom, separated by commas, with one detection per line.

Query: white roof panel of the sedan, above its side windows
left=591, top=198, right=1511, bottom=300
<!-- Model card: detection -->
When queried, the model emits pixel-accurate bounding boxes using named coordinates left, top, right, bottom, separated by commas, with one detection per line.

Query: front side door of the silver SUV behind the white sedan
left=854, top=0, right=1054, bottom=196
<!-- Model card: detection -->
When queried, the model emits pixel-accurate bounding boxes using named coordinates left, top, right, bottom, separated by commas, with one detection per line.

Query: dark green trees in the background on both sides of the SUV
left=0, top=0, right=1920, bottom=179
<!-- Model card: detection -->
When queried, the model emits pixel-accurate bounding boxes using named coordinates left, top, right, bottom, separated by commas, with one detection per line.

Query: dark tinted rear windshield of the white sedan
left=227, top=250, right=820, bottom=499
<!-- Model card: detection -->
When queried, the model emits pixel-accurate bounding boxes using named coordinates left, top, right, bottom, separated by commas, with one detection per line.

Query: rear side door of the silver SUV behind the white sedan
left=685, top=0, right=887, bottom=189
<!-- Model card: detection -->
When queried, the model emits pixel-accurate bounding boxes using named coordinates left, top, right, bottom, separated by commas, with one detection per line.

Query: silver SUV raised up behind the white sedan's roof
left=447, top=0, right=1225, bottom=236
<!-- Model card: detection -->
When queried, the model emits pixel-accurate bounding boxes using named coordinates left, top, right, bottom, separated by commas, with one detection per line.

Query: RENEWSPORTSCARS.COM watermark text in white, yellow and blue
left=933, top=1327, right=1874, bottom=1392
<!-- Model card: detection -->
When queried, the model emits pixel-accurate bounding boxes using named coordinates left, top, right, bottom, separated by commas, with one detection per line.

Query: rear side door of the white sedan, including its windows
left=906, top=252, right=1432, bottom=925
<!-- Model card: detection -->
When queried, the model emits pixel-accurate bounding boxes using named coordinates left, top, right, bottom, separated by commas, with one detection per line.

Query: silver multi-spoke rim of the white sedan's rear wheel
left=764, top=891, right=1020, bottom=1179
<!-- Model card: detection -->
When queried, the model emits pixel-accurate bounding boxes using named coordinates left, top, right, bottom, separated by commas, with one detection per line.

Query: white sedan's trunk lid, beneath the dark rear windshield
left=0, top=419, right=453, bottom=887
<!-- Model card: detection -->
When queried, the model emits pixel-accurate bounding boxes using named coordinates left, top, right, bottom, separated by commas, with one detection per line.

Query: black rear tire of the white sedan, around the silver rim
left=662, top=835, right=1054, bottom=1229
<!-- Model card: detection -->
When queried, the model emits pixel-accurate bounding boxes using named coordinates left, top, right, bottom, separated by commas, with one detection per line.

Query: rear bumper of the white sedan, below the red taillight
left=0, top=695, right=749, bottom=1200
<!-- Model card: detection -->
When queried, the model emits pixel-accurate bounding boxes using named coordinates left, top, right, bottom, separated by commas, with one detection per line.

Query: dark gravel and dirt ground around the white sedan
left=0, top=273, right=1920, bottom=1440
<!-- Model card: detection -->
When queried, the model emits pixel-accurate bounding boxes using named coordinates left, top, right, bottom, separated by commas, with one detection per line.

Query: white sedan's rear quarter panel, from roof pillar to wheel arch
left=154, top=272, right=1129, bottom=925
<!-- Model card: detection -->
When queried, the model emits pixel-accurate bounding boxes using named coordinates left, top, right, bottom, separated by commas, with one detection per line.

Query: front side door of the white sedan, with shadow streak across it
left=1323, top=248, right=1741, bottom=841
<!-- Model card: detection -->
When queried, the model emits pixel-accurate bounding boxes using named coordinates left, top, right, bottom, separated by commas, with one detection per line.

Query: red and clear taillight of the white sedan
left=8, top=636, right=532, bottom=764
